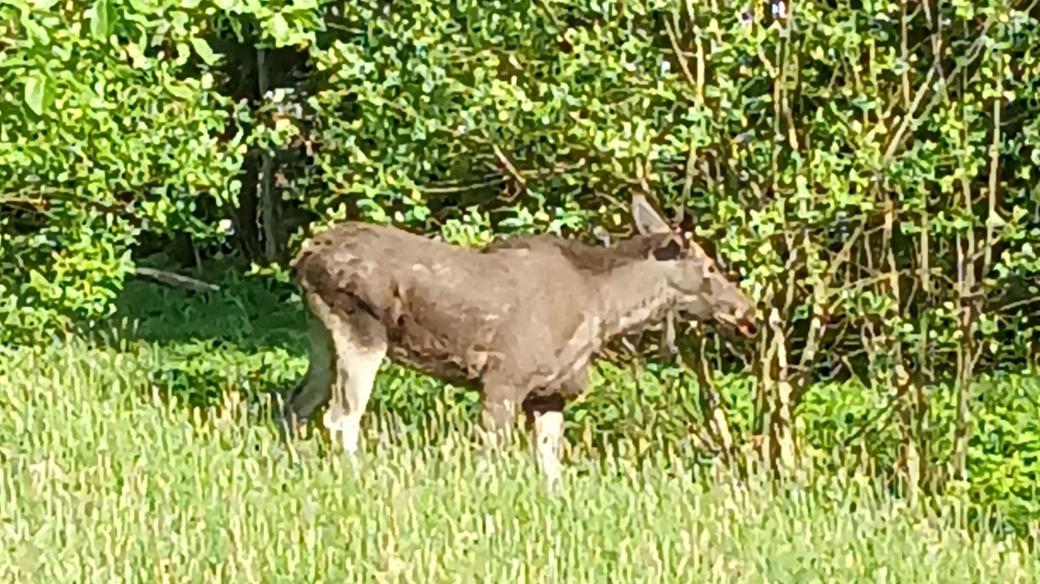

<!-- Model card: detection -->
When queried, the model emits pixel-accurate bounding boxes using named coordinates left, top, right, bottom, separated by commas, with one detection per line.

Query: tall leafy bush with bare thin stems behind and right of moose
left=276, top=1, right=1040, bottom=505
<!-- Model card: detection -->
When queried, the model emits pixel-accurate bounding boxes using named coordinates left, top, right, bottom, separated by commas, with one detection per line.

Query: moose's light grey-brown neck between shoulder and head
left=599, top=260, right=679, bottom=339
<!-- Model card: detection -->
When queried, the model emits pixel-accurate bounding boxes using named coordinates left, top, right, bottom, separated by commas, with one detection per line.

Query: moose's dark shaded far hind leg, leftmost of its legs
left=281, top=314, right=334, bottom=434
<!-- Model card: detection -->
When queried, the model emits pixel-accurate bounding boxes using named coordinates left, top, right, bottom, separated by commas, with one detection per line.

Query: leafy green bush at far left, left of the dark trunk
left=0, top=1, right=236, bottom=342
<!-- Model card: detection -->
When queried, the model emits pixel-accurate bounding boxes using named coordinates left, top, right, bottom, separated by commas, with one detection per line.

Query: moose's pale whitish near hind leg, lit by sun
left=323, top=301, right=387, bottom=456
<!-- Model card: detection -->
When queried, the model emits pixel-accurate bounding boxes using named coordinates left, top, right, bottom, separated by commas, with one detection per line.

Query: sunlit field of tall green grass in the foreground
left=0, top=343, right=1040, bottom=583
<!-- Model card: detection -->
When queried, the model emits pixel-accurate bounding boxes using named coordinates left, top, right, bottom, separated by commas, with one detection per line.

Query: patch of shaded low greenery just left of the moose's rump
left=95, top=256, right=308, bottom=407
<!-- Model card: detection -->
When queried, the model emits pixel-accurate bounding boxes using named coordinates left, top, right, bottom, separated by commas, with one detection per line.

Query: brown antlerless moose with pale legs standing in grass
left=280, top=194, right=756, bottom=482
